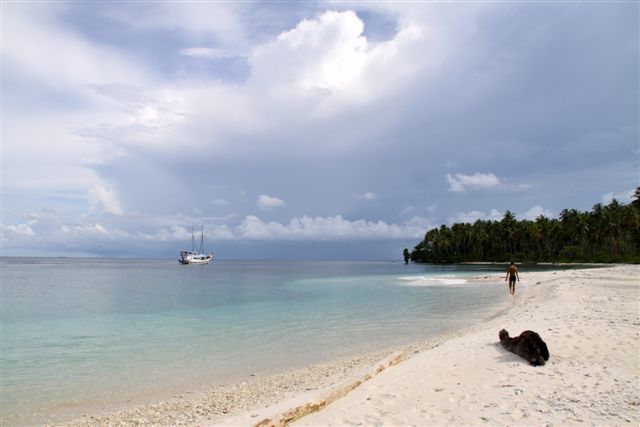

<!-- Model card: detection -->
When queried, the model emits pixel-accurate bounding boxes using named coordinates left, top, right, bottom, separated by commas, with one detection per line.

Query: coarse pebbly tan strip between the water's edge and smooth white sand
left=52, top=314, right=502, bottom=427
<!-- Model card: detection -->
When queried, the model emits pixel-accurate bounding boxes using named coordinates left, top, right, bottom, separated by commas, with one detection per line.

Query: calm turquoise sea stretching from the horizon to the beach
left=0, top=258, right=508, bottom=420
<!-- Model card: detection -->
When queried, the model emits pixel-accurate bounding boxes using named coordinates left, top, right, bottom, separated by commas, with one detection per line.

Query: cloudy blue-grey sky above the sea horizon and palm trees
left=0, top=1, right=640, bottom=260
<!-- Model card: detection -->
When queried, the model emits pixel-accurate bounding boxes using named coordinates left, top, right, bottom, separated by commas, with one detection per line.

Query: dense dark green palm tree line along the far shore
left=403, top=187, right=640, bottom=263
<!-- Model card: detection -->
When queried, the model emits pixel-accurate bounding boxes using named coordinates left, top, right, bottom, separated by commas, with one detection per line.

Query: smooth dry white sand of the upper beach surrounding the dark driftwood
left=232, top=266, right=640, bottom=426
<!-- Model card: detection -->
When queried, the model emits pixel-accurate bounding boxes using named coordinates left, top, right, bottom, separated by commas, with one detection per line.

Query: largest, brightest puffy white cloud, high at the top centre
left=250, top=11, right=422, bottom=108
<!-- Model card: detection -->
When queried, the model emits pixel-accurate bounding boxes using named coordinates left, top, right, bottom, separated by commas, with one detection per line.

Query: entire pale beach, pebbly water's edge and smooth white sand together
left=52, top=266, right=640, bottom=426
